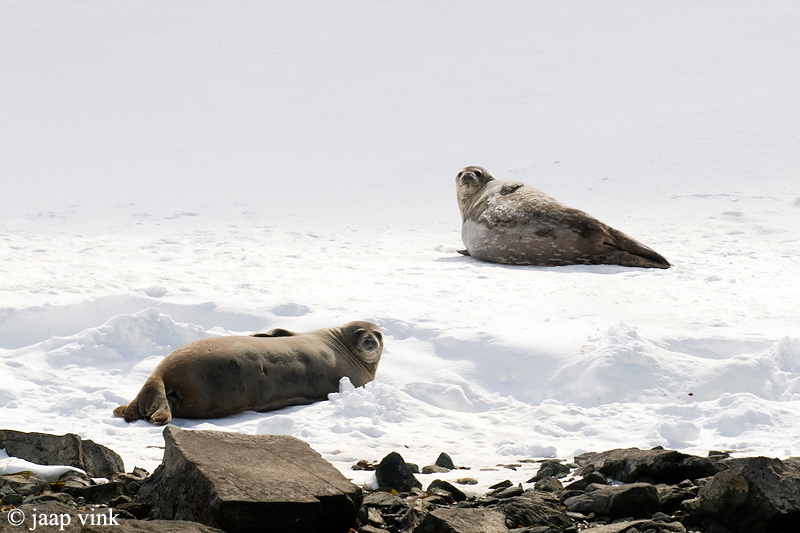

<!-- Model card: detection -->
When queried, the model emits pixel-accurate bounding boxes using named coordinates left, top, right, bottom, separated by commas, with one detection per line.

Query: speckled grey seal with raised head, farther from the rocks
left=456, top=167, right=670, bottom=268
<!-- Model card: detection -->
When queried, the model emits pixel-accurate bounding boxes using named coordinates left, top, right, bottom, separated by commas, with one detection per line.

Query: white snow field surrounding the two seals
left=0, top=1, right=800, bottom=491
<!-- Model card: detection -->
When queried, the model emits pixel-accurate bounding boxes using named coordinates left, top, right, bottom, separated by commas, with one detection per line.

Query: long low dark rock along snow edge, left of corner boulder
left=575, top=448, right=717, bottom=485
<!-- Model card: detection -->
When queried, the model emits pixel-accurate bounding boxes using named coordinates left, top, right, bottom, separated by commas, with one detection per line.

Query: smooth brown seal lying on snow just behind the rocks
left=114, top=322, right=383, bottom=426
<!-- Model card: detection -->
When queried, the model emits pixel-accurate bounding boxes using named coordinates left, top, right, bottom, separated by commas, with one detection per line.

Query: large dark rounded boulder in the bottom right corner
left=683, top=457, right=800, bottom=533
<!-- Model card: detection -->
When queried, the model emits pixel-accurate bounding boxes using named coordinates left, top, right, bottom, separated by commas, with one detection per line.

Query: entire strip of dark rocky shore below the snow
left=0, top=427, right=800, bottom=533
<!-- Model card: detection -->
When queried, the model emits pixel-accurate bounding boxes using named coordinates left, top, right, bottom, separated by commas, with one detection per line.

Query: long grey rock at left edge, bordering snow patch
left=0, top=429, right=125, bottom=477
